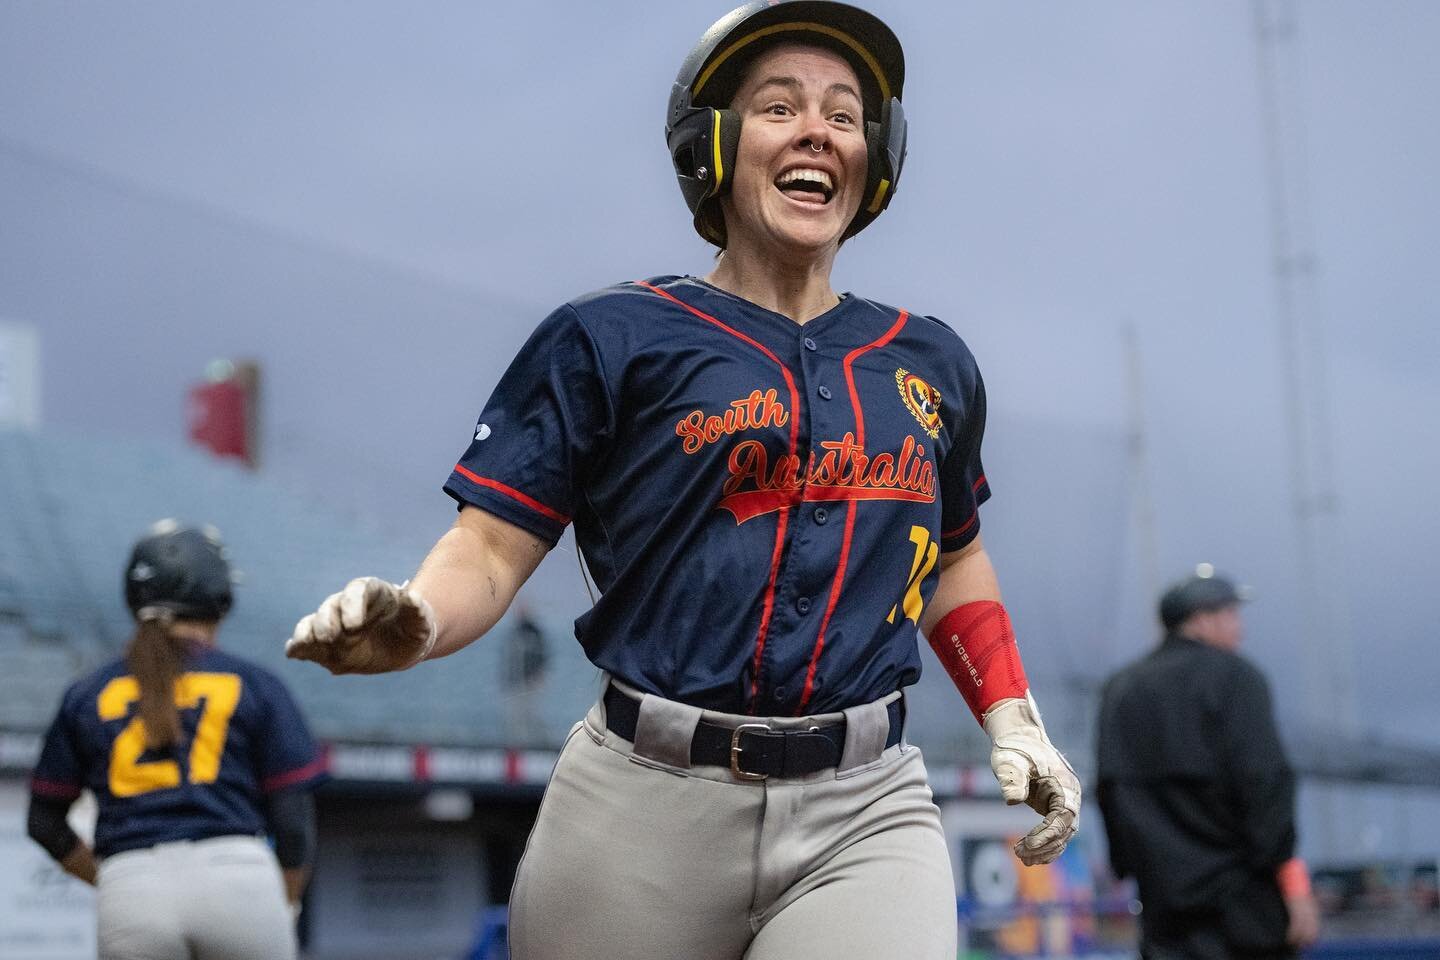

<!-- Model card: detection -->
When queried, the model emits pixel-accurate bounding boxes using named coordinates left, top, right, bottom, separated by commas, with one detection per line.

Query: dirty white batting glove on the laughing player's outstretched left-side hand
left=285, top=577, right=436, bottom=674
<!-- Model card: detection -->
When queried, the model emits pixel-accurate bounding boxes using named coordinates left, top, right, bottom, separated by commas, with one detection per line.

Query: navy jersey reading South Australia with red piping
left=445, top=276, right=989, bottom=715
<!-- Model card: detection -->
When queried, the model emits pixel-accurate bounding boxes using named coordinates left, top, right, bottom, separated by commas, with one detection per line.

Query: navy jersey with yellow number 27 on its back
left=30, top=648, right=325, bottom=856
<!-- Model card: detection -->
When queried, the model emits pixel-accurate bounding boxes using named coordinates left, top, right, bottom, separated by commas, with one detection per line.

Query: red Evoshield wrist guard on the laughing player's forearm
left=930, top=600, right=1030, bottom=723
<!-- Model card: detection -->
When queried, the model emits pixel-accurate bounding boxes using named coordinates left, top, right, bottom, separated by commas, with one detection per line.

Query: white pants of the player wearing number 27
left=96, top=836, right=297, bottom=960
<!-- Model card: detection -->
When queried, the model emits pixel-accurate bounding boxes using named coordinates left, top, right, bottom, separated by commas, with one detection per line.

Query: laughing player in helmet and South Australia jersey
left=288, top=0, right=1080, bottom=960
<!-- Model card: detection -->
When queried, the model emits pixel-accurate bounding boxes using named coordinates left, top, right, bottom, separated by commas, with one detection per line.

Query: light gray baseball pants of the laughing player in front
left=510, top=682, right=956, bottom=960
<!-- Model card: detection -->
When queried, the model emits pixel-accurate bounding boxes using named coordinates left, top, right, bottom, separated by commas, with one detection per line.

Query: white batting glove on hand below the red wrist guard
left=984, top=689, right=1080, bottom=866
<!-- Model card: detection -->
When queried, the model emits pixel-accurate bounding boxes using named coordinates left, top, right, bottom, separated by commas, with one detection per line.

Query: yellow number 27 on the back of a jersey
left=95, top=674, right=240, bottom=797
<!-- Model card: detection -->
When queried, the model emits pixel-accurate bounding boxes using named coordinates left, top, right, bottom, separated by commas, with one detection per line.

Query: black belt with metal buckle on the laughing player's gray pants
left=605, top=685, right=904, bottom=780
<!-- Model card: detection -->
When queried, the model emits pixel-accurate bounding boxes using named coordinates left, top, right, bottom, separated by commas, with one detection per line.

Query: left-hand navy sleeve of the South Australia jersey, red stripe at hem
left=445, top=305, right=615, bottom=545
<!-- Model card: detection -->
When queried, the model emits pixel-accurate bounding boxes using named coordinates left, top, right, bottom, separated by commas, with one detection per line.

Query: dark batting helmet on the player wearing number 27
left=125, top=520, right=232, bottom=620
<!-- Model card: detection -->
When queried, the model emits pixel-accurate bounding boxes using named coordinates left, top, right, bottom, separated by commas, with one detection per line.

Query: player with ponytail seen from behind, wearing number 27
left=29, top=521, right=324, bottom=960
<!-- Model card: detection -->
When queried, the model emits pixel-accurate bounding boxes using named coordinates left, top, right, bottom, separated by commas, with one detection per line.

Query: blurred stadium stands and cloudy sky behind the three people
left=0, top=0, right=1440, bottom=960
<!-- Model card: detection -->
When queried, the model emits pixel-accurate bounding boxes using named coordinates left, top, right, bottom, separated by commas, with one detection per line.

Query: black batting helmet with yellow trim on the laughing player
left=665, top=0, right=906, bottom=246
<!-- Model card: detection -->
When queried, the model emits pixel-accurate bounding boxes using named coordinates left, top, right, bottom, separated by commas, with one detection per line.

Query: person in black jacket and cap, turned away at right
left=1097, top=564, right=1319, bottom=960
